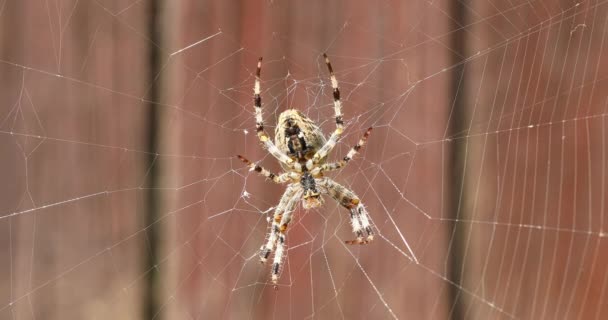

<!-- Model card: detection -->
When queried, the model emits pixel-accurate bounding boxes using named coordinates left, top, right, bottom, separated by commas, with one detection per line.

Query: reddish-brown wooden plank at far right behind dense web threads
left=460, top=1, right=608, bottom=319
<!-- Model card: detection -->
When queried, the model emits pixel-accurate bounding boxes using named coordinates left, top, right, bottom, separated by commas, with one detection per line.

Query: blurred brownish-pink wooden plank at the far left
left=0, top=1, right=146, bottom=319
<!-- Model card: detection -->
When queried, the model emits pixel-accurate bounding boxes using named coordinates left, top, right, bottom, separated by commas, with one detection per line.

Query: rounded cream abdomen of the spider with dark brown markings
left=274, top=109, right=326, bottom=166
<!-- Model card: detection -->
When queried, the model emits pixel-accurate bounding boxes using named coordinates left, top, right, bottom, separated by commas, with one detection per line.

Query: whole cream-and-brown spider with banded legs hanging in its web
left=238, top=54, right=374, bottom=288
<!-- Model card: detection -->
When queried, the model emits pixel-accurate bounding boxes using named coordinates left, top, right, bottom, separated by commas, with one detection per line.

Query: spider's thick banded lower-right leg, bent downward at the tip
left=317, top=178, right=374, bottom=244
